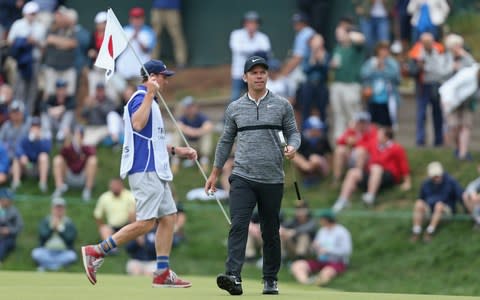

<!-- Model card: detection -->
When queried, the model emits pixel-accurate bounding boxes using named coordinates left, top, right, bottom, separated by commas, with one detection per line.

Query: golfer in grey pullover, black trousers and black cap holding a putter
left=205, top=56, right=300, bottom=295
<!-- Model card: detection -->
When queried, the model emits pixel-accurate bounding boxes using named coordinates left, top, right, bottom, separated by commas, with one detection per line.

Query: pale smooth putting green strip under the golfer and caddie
left=0, top=271, right=478, bottom=300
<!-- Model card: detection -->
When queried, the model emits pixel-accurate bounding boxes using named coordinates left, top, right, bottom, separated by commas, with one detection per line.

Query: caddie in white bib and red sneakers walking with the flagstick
left=82, top=60, right=197, bottom=288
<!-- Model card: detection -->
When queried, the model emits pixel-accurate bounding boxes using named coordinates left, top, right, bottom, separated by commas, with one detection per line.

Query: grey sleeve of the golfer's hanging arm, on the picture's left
left=213, top=106, right=237, bottom=169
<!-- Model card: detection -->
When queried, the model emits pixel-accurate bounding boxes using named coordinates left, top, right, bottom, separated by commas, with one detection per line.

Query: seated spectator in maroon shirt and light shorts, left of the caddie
left=53, top=126, right=97, bottom=201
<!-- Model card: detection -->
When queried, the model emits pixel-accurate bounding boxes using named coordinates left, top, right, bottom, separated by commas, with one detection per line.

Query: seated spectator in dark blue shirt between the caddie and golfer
left=172, top=96, right=213, bottom=174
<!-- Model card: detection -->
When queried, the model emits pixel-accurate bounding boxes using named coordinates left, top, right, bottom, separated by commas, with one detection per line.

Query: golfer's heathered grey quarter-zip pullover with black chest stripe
left=214, top=91, right=300, bottom=183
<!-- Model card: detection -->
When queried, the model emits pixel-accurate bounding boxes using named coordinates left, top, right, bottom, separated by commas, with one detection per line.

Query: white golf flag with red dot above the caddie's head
left=95, top=8, right=127, bottom=81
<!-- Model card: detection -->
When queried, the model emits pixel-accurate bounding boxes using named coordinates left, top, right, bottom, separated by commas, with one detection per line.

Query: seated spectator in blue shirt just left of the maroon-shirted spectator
left=12, top=117, right=52, bottom=193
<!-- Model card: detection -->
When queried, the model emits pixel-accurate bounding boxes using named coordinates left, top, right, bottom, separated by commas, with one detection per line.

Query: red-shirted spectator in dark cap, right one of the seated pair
left=332, top=128, right=411, bottom=212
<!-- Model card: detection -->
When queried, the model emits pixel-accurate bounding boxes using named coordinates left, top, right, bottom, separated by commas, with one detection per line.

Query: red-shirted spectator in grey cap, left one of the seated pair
left=333, top=112, right=377, bottom=186
